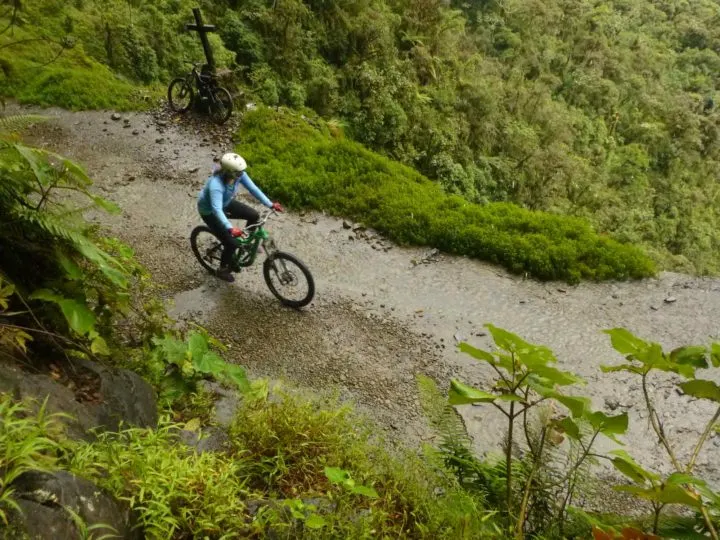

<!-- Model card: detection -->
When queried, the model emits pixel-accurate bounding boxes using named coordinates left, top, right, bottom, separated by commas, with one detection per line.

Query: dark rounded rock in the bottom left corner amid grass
left=6, top=471, right=143, bottom=540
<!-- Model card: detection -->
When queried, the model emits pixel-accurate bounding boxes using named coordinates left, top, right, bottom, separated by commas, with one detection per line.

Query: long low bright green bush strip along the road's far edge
left=239, top=109, right=655, bottom=282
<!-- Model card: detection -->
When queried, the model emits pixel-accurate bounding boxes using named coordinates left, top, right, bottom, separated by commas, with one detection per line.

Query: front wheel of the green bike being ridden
left=263, top=251, right=315, bottom=308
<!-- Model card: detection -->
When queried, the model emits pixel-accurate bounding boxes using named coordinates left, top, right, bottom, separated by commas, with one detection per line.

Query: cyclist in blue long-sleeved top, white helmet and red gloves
left=198, top=153, right=285, bottom=282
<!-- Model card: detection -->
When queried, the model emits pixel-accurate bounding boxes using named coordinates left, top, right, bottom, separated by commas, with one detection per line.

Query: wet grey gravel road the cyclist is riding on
left=24, top=104, right=720, bottom=481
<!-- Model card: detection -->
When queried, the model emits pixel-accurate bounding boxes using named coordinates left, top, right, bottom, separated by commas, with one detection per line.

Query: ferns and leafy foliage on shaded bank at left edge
left=0, top=116, right=132, bottom=356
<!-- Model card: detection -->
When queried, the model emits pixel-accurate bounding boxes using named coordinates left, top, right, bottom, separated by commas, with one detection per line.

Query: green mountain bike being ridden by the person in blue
left=190, top=210, right=315, bottom=308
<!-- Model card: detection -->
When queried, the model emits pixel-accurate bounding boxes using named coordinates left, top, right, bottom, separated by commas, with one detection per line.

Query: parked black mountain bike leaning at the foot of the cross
left=168, top=62, right=233, bottom=124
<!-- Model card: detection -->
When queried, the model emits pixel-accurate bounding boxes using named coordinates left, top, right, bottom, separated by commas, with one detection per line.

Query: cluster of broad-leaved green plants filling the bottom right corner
left=438, top=324, right=720, bottom=539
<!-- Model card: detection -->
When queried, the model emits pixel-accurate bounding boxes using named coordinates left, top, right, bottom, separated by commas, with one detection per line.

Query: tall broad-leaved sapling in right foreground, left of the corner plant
left=449, top=324, right=628, bottom=538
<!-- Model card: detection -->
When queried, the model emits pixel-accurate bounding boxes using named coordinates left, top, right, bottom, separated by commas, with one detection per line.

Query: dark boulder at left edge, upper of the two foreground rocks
left=0, top=360, right=158, bottom=439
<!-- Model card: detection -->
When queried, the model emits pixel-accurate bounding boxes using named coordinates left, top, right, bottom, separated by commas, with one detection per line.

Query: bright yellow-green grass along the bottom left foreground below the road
left=0, top=393, right=494, bottom=539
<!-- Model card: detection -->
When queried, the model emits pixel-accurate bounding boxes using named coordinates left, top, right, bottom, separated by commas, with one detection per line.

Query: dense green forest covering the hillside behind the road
left=5, top=0, right=720, bottom=273
